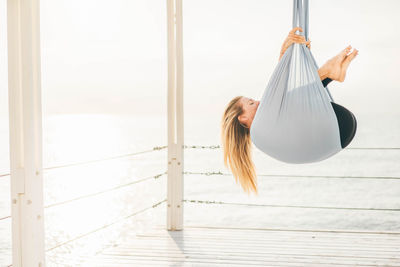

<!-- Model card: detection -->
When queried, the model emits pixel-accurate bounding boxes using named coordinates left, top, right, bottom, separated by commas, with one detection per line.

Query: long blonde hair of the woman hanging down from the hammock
left=221, top=96, right=258, bottom=195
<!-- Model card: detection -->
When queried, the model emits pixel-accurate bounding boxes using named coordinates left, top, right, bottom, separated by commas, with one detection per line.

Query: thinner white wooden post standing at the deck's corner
left=167, top=0, right=183, bottom=230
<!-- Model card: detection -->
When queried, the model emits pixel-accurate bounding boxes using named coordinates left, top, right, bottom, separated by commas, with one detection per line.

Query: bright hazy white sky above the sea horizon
left=0, top=0, right=400, bottom=115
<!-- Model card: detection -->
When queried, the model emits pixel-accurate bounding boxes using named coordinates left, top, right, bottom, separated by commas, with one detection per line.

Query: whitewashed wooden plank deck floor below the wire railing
left=85, top=226, right=400, bottom=267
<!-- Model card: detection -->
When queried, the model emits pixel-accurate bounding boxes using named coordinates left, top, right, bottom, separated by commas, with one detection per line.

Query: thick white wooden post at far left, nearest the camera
left=7, top=0, right=45, bottom=267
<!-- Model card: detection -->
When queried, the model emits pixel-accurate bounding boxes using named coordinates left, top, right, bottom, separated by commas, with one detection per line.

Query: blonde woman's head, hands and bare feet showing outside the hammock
left=221, top=27, right=358, bottom=194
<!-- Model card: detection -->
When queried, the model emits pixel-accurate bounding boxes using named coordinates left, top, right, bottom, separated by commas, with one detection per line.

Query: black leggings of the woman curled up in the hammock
left=322, top=78, right=357, bottom=148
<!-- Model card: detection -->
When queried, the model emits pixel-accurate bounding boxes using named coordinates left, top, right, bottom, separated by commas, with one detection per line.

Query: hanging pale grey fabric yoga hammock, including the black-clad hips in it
left=250, top=0, right=357, bottom=163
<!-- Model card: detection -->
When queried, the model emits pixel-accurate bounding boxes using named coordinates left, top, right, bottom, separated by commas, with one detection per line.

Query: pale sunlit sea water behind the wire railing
left=0, top=112, right=400, bottom=266
